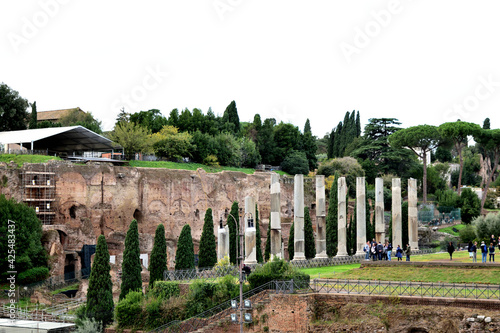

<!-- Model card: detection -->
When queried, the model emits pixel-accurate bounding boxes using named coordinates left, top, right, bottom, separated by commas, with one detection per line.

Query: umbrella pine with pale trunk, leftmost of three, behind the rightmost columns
left=389, top=125, right=441, bottom=204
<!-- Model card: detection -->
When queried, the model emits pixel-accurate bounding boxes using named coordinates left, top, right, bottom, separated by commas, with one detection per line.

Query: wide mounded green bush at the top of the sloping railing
left=248, top=259, right=310, bottom=289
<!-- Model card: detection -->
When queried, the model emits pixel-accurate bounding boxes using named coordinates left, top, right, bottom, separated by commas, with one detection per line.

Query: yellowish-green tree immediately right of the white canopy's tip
left=110, top=122, right=152, bottom=155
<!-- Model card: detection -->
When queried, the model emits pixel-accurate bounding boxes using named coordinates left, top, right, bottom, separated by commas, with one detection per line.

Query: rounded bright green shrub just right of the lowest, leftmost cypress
left=116, top=291, right=144, bottom=328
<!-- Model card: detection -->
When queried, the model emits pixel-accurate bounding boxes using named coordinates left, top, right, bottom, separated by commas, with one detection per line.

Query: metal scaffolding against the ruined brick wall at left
left=21, top=164, right=56, bottom=224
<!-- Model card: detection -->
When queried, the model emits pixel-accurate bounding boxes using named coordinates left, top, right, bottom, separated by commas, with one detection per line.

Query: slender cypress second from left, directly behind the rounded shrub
left=120, top=219, right=142, bottom=300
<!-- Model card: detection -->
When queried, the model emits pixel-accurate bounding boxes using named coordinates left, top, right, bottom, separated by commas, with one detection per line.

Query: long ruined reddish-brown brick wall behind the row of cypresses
left=0, top=162, right=315, bottom=267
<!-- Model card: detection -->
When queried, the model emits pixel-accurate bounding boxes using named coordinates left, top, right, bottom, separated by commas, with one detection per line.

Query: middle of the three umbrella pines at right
left=438, top=120, right=481, bottom=195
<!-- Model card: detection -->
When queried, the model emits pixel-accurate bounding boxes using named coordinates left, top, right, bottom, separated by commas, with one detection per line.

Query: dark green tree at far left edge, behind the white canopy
left=0, top=82, right=29, bottom=132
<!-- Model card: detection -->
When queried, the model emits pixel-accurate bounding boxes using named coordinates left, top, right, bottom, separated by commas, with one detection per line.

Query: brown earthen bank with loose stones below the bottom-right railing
left=310, top=299, right=500, bottom=333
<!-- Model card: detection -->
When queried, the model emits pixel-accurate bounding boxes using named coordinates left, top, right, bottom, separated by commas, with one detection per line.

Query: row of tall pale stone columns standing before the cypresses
left=218, top=173, right=418, bottom=264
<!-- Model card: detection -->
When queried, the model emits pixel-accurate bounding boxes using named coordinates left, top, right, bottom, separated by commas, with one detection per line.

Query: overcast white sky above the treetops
left=0, top=0, right=500, bottom=136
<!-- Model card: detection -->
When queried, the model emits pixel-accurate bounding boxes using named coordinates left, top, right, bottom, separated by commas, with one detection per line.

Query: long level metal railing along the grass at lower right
left=311, top=279, right=500, bottom=300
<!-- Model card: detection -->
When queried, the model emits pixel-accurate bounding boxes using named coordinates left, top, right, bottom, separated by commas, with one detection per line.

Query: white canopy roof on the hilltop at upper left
left=0, top=126, right=121, bottom=153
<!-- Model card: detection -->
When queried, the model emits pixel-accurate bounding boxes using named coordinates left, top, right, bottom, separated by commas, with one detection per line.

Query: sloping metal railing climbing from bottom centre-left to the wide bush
left=148, top=280, right=313, bottom=333
